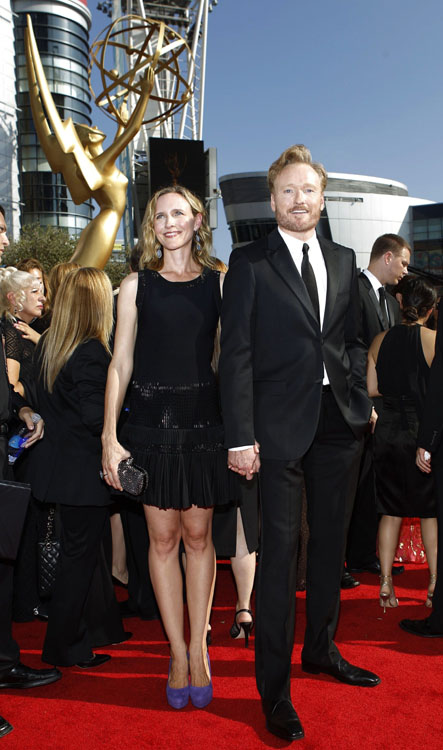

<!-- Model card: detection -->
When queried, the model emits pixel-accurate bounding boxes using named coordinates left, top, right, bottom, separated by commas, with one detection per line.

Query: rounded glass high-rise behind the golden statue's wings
left=13, top=0, right=92, bottom=235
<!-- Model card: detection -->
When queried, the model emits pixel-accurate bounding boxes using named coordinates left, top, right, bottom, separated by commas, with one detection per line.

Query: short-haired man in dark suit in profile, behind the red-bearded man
left=346, top=234, right=411, bottom=575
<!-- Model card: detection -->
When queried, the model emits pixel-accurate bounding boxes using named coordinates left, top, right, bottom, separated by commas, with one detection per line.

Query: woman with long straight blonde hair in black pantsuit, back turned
left=26, top=268, right=124, bottom=667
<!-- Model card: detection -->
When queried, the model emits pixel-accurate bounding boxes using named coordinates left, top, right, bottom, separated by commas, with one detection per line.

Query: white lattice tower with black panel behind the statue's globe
left=98, top=0, right=218, bottom=245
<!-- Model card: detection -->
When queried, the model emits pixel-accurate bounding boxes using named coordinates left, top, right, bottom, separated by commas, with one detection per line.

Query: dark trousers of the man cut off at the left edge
left=0, top=435, right=20, bottom=676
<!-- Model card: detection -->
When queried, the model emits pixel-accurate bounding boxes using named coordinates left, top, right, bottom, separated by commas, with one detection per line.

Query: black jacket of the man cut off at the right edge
left=417, top=302, right=443, bottom=452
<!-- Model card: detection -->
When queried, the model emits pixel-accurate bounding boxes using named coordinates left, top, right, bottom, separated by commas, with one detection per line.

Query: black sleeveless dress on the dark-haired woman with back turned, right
left=374, top=325, right=437, bottom=518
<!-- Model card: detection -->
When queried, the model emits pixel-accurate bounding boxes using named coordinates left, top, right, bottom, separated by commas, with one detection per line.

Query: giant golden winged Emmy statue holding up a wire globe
left=25, top=16, right=192, bottom=268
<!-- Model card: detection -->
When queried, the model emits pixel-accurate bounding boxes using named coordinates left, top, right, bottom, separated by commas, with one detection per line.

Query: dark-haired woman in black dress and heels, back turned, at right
left=368, top=276, right=437, bottom=611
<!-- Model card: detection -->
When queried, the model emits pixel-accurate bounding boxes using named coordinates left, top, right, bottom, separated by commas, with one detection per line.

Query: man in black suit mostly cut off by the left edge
left=0, top=206, right=61, bottom=737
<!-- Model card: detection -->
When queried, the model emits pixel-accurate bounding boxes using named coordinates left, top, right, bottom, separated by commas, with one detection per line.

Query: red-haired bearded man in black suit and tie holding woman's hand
left=220, top=146, right=380, bottom=740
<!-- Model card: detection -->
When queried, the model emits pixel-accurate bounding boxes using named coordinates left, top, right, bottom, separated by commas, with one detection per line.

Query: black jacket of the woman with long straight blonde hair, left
left=20, top=339, right=111, bottom=506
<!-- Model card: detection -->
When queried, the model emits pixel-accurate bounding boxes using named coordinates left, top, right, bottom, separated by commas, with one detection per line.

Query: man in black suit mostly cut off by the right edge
left=399, top=302, right=443, bottom=638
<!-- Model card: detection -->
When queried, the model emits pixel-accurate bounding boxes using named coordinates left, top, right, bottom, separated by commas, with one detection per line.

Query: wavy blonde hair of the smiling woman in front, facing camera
left=139, top=185, right=226, bottom=271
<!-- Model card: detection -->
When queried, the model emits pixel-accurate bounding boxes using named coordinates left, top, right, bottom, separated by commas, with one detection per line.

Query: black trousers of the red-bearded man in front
left=255, top=392, right=361, bottom=701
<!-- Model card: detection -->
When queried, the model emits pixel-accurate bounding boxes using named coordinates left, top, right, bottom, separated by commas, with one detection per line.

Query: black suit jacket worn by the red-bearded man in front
left=219, top=229, right=371, bottom=460
